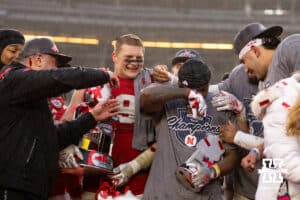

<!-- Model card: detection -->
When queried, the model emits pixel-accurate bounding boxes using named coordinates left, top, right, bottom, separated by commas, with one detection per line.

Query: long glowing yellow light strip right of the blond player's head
left=112, top=40, right=233, bottom=50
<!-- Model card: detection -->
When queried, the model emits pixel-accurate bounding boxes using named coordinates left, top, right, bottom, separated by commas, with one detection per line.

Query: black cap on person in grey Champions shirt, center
left=178, top=59, right=211, bottom=89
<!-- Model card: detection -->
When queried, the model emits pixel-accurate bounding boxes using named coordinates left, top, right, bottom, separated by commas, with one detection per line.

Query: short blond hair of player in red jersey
left=114, top=33, right=145, bottom=54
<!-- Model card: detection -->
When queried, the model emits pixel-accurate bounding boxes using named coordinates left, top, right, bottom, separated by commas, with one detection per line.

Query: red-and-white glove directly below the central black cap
left=188, top=90, right=207, bottom=118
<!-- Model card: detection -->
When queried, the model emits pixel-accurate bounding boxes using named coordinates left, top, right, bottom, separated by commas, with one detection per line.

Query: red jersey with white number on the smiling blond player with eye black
left=111, top=77, right=148, bottom=195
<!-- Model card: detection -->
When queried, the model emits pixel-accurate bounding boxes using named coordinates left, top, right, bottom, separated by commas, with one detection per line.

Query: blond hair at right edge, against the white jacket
left=286, top=96, right=300, bottom=136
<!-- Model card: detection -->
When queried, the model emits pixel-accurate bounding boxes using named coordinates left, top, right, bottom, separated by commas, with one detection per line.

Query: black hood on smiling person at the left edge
left=0, top=29, right=25, bottom=70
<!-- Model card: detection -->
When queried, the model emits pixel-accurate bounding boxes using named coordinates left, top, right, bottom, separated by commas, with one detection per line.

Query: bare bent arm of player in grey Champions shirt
left=140, top=86, right=190, bottom=114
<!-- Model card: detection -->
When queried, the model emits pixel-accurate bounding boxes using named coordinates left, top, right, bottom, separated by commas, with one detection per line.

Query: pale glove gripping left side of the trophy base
left=58, top=144, right=83, bottom=169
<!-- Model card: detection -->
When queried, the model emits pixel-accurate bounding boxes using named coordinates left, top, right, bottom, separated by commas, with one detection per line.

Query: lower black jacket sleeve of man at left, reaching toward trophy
left=56, top=112, right=97, bottom=150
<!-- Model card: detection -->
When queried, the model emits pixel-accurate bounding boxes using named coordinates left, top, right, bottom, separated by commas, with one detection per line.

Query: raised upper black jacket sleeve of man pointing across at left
left=5, top=67, right=109, bottom=104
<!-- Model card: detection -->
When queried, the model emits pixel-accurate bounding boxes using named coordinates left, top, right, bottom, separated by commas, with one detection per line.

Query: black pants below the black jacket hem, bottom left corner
left=0, top=188, right=47, bottom=200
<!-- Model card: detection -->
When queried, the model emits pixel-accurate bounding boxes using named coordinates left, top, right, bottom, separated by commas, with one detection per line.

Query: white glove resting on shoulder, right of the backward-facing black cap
left=211, top=90, right=244, bottom=114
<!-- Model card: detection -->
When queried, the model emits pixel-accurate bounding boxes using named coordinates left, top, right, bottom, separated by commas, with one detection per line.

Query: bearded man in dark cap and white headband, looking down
left=234, top=23, right=300, bottom=88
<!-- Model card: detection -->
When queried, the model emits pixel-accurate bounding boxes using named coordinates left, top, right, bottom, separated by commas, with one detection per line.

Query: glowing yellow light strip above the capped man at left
left=25, top=34, right=99, bottom=45
